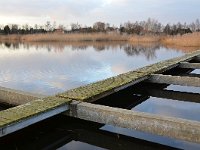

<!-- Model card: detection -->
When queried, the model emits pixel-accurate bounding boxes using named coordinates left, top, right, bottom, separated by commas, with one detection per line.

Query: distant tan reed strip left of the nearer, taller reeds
left=0, top=33, right=159, bottom=43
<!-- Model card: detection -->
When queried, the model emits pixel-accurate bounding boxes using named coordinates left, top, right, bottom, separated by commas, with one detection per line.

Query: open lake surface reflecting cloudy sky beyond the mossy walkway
left=0, top=43, right=184, bottom=95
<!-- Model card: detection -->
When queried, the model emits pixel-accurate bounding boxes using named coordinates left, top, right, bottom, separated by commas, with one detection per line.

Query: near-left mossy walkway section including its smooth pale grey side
left=0, top=97, right=71, bottom=137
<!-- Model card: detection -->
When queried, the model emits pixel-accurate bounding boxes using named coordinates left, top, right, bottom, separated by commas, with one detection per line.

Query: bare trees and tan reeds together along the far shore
left=0, top=18, right=200, bottom=47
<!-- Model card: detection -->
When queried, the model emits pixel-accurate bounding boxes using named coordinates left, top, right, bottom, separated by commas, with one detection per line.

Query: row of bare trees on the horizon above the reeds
left=0, top=18, right=200, bottom=35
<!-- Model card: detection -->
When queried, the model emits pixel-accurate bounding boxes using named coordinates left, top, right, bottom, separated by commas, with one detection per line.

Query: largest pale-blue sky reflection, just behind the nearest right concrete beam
left=133, top=97, right=200, bottom=121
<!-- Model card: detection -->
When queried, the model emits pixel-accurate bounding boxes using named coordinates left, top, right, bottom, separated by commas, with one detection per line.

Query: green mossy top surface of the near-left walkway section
left=0, top=97, right=71, bottom=127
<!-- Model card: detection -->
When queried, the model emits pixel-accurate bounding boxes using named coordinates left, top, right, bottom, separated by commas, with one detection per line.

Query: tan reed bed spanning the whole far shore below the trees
left=0, top=32, right=200, bottom=47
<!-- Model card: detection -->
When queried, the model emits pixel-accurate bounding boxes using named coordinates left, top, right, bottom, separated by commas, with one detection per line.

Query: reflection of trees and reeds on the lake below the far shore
left=2, top=41, right=198, bottom=60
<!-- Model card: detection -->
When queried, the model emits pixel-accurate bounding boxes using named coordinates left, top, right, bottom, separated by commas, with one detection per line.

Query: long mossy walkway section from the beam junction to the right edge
left=56, top=50, right=200, bottom=102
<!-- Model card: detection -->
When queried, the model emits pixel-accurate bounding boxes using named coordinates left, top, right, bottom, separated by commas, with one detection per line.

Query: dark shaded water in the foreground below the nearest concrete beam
left=0, top=116, right=178, bottom=150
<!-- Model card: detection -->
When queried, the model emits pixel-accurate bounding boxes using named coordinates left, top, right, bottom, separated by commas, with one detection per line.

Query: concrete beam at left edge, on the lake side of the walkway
left=0, top=87, right=46, bottom=106
